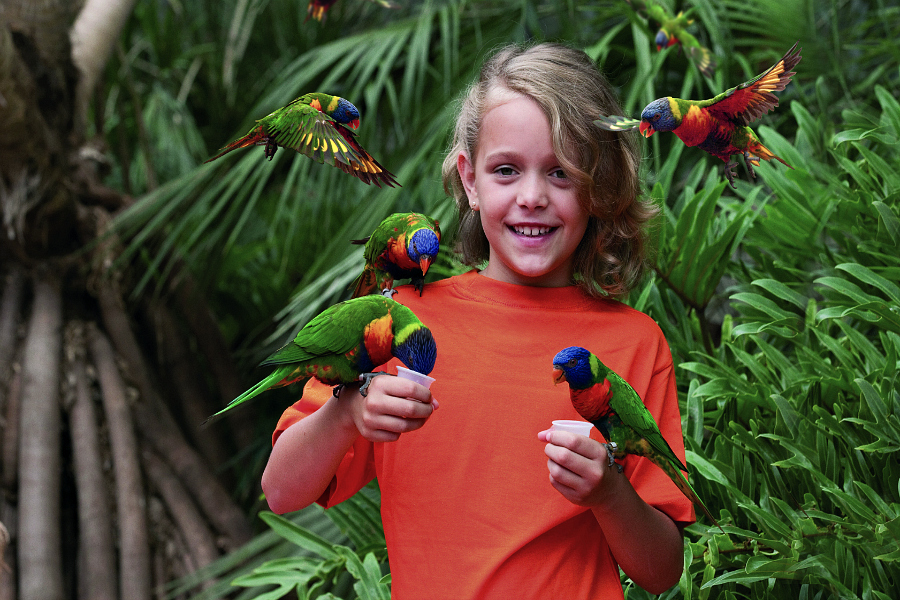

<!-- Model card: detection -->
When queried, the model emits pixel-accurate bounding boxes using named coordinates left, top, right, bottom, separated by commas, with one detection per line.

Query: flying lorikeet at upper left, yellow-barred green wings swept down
left=205, top=93, right=398, bottom=187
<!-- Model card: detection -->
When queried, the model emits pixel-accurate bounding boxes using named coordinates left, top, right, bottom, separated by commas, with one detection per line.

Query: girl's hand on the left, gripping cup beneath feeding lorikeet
left=338, top=376, right=438, bottom=442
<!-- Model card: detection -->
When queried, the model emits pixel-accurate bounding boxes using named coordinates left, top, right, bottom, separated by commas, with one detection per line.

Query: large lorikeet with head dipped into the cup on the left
left=204, top=294, right=437, bottom=424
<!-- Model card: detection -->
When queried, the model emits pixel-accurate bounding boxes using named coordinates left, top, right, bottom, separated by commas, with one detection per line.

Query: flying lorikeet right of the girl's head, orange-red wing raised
left=594, top=44, right=800, bottom=187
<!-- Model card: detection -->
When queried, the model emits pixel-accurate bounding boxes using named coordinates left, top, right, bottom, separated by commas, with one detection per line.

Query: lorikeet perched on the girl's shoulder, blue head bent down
left=353, top=213, right=441, bottom=298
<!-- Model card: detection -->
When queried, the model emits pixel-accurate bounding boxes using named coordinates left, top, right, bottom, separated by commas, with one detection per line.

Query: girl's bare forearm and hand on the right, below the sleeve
left=538, top=431, right=684, bottom=594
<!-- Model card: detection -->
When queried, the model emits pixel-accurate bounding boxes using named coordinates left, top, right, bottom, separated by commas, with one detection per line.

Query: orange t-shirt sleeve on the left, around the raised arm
left=272, top=378, right=375, bottom=508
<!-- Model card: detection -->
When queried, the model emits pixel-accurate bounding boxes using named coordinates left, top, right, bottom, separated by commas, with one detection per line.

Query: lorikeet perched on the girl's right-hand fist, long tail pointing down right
left=553, top=346, right=719, bottom=526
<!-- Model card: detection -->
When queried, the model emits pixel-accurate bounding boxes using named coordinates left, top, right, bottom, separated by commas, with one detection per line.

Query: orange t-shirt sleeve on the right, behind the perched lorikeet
left=626, top=339, right=697, bottom=525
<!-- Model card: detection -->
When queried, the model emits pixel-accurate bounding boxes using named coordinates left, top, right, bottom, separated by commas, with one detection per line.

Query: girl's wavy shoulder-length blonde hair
left=443, top=43, right=657, bottom=297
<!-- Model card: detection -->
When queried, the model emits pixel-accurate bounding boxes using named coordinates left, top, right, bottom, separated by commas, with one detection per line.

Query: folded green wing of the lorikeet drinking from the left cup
left=261, top=296, right=393, bottom=366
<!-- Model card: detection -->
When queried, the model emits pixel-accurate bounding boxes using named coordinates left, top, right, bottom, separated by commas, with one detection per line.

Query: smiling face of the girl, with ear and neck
left=457, top=90, right=588, bottom=287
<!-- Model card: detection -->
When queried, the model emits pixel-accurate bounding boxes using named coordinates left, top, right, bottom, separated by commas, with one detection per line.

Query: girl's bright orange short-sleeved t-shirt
left=273, top=271, right=694, bottom=600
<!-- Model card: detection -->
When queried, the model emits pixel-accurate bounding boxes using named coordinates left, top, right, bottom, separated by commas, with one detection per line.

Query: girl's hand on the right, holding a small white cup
left=538, top=429, right=627, bottom=508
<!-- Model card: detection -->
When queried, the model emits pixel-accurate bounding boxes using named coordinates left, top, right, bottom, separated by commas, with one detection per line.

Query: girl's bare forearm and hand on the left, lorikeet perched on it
left=262, top=376, right=438, bottom=514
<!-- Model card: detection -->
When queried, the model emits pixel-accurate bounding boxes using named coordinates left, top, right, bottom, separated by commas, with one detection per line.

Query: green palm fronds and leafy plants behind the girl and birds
left=94, top=0, right=900, bottom=599
